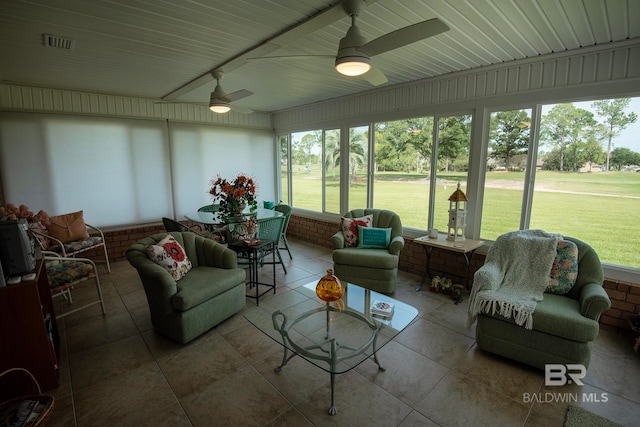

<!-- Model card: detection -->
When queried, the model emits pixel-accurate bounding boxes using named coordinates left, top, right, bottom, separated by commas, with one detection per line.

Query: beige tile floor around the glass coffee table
left=50, top=241, right=640, bottom=427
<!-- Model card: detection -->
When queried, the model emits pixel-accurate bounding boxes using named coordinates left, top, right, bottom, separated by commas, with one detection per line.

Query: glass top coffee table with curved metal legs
left=244, top=281, right=418, bottom=415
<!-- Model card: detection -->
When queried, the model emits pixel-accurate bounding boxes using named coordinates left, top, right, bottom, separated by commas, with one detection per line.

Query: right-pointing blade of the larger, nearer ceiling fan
left=358, top=18, right=449, bottom=56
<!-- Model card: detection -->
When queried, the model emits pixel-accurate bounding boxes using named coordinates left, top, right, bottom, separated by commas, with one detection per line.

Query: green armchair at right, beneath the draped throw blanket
left=476, top=236, right=611, bottom=369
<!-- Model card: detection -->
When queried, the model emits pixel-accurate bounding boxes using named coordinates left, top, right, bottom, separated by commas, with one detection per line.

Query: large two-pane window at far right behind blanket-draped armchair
left=481, top=98, right=640, bottom=268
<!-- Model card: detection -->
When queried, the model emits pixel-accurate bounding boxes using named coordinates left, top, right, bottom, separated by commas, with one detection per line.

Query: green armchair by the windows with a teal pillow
left=331, top=209, right=404, bottom=293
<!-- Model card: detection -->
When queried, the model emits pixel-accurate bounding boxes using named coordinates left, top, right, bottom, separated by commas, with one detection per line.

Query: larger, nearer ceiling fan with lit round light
left=250, top=0, right=449, bottom=86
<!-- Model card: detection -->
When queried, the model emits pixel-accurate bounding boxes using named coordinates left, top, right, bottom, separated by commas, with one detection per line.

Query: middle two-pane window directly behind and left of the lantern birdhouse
left=373, top=115, right=471, bottom=230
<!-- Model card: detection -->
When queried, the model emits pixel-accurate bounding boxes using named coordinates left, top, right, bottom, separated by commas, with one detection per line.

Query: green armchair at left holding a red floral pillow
left=126, top=232, right=245, bottom=344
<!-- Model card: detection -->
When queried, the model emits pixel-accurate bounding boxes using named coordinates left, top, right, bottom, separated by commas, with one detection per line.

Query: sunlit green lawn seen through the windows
left=293, top=169, right=640, bottom=268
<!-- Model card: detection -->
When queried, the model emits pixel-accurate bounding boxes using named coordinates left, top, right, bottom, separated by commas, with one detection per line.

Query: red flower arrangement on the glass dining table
left=209, top=174, right=258, bottom=217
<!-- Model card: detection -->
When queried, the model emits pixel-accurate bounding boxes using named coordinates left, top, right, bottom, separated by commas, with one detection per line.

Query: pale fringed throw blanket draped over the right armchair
left=468, top=230, right=562, bottom=329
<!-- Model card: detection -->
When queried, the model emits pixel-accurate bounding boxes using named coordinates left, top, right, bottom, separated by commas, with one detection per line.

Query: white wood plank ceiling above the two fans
left=0, top=0, right=640, bottom=111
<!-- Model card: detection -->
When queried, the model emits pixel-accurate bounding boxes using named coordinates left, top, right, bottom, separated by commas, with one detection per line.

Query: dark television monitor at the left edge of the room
left=0, top=219, right=36, bottom=278
